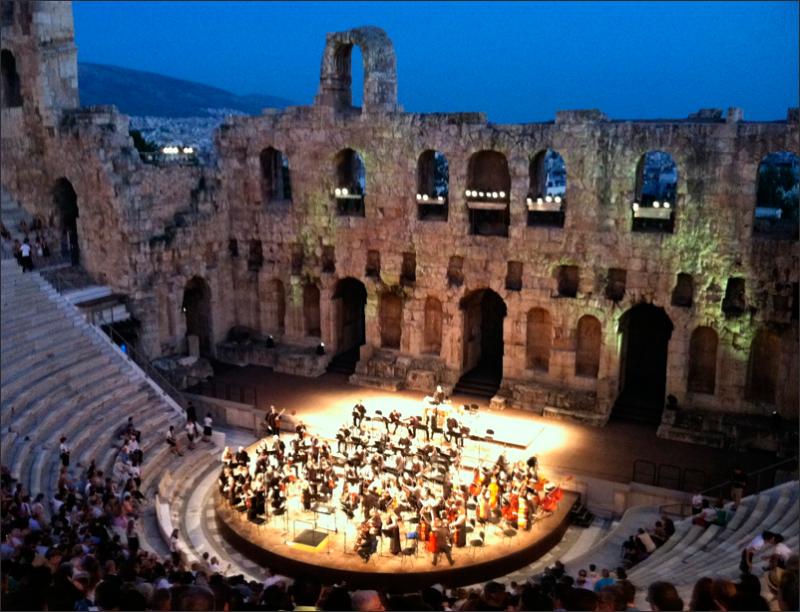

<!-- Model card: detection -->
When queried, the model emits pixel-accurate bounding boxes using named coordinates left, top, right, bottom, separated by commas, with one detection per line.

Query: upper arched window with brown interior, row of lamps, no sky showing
left=465, top=151, right=511, bottom=236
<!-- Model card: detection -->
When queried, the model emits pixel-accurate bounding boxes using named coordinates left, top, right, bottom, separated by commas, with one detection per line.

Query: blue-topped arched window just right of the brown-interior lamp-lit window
left=525, top=149, right=567, bottom=227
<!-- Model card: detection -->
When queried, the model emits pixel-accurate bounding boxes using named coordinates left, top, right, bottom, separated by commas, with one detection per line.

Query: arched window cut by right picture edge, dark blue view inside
left=753, top=151, right=800, bottom=240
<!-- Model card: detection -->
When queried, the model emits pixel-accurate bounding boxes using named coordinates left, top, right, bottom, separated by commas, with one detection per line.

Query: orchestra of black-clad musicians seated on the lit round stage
left=219, top=402, right=563, bottom=565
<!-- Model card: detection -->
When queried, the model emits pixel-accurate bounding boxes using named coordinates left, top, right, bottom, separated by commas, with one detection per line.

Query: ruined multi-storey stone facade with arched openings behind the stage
left=2, top=0, right=800, bottom=440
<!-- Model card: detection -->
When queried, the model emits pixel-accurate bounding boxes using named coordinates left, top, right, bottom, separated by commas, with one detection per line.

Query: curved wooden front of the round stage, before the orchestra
left=214, top=490, right=578, bottom=591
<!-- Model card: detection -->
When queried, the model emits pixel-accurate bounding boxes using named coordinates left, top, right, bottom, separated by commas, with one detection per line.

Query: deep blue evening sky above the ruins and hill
left=73, top=1, right=800, bottom=123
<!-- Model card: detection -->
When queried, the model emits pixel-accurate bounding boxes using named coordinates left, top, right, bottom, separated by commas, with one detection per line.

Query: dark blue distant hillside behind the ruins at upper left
left=78, top=62, right=294, bottom=117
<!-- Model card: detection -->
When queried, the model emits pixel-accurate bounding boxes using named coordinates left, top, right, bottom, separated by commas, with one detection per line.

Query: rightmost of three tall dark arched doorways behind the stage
left=614, top=304, right=673, bottom=423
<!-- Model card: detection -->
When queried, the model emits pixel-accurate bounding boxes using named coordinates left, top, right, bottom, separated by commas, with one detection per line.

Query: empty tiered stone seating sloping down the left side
left=0, top=260, right=183, bottom=520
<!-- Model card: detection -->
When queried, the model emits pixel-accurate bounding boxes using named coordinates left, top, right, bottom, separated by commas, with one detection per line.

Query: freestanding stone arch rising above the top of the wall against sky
left=316, top=26, right=401, bottom=113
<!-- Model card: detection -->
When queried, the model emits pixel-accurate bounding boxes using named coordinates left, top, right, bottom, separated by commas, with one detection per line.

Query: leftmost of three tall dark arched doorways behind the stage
left=328, top=278, right=367, bottom=374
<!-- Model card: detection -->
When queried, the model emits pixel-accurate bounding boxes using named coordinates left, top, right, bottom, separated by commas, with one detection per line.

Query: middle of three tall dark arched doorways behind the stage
left=456, top=289, right=508, bottom=397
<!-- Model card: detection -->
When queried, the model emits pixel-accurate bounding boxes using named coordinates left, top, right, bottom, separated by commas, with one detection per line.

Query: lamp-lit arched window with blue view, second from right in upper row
left=631, top=151, right=678, bottom=233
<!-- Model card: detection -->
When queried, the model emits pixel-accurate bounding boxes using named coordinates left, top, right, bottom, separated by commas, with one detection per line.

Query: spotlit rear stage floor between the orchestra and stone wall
left=203, top=366, right=774, bottom=486
